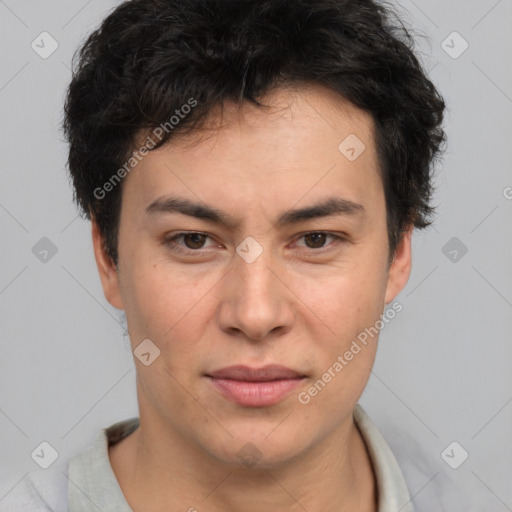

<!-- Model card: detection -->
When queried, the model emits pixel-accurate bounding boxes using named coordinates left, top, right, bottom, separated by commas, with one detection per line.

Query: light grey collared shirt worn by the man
left=0, top=404, right=415, bottom=512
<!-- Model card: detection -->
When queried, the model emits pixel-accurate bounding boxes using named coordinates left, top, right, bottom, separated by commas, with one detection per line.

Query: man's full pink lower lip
left=208, top=377, right=303, bottom=407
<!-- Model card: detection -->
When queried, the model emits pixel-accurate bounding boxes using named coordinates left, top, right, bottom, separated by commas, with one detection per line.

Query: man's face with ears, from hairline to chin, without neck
left=95, top=86, right=410, bottom=467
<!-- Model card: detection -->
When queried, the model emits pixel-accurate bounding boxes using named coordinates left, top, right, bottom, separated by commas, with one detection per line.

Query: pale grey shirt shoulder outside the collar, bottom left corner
left=0, top=461, right=68, bottom=512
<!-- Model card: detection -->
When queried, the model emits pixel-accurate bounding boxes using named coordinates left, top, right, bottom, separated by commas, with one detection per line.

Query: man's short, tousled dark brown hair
left=62, top=0, right=446, bottom=264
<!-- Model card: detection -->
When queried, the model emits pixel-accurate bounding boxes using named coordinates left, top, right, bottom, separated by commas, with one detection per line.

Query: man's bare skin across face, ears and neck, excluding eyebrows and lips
left=92, top=85, right=412, bottom=512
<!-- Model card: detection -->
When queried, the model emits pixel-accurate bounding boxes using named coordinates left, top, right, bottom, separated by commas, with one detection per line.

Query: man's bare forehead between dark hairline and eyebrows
left=123, top=84, right=381, bottom=222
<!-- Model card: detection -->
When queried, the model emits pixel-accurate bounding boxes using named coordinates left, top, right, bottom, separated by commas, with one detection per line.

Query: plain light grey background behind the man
left=0, top=0, right=512, bottom=512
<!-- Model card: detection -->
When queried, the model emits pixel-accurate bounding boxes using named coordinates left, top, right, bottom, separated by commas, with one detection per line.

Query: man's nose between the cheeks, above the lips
left=218, top=246, right=295, bottom=341
